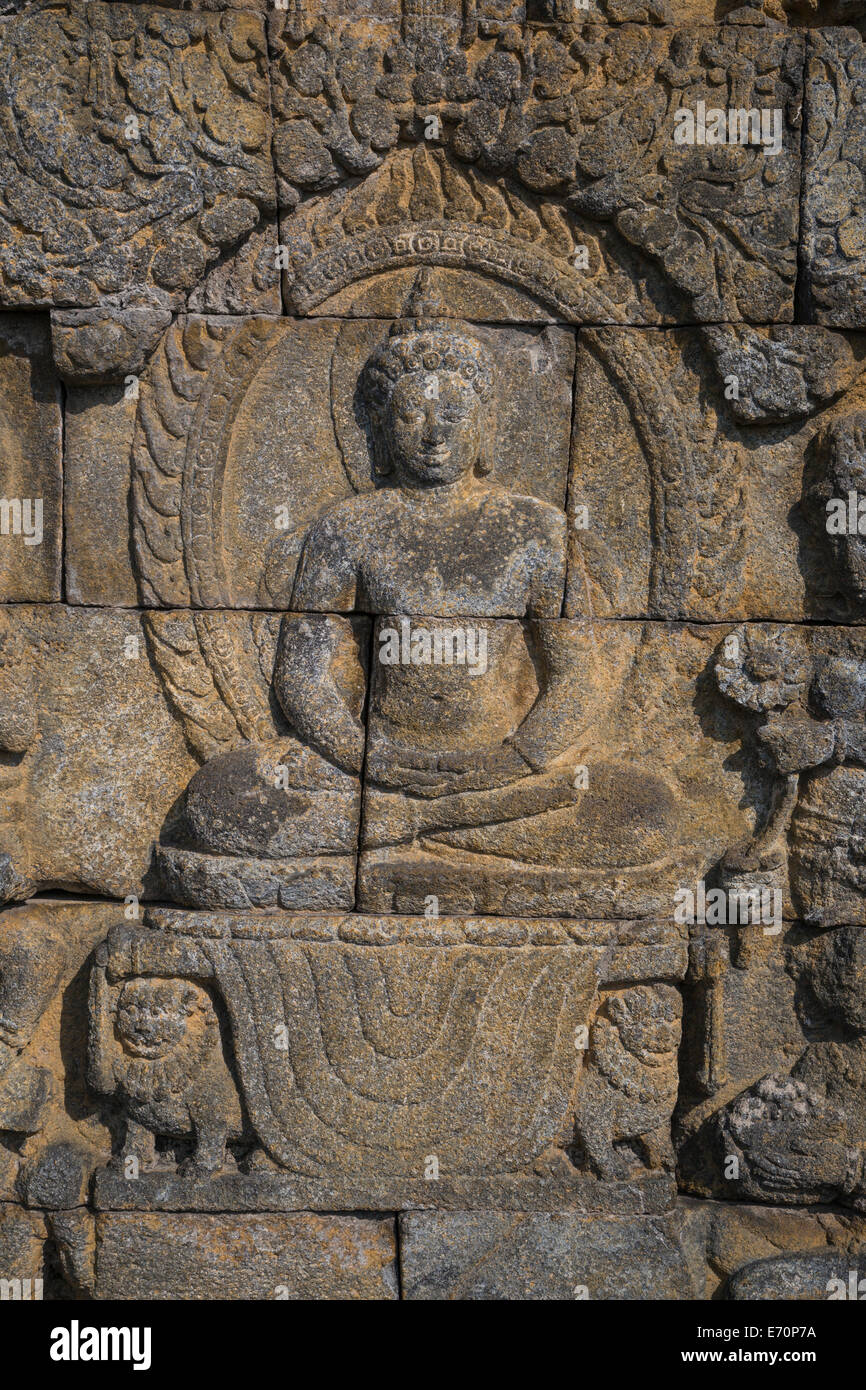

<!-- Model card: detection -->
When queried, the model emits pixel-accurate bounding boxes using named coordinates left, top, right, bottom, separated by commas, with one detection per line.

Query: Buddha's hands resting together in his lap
left=367, top=739, right=532, bottom=798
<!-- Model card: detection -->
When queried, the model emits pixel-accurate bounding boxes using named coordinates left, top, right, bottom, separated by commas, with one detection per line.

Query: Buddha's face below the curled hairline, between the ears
left=385, top=371, right=481, bottom=487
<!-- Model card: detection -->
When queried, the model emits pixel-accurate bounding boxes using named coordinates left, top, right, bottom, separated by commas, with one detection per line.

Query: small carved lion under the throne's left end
left=111, top=979, right=243, bottom=1176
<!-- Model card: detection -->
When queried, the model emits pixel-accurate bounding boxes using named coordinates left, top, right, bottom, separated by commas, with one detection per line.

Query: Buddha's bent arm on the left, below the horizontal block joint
left=274, top=613, right=364, bottom=773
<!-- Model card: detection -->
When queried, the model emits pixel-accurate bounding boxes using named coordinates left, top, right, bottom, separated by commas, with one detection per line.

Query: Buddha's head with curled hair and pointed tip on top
left=364, top=271, right=493, bottom=488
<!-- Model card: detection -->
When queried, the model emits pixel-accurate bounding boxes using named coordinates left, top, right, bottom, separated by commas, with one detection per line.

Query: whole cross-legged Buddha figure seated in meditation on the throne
left=167, top=272, right=683, bottom=906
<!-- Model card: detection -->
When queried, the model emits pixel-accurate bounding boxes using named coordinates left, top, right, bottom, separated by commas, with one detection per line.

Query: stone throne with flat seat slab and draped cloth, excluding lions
left=90, top=908, right=687, bottom=1209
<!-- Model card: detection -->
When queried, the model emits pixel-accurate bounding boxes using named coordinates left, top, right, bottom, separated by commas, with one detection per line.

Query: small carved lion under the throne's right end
left=575, top=984, right=683, bottom=1182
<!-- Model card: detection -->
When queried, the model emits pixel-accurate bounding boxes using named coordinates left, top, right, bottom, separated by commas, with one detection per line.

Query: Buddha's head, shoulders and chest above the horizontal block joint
left=291, top=278, right=566, bottom=617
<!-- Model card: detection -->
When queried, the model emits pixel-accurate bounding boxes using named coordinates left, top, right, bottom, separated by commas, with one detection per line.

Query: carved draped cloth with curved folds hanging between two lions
left=206, top=941, right=596, bottom=1179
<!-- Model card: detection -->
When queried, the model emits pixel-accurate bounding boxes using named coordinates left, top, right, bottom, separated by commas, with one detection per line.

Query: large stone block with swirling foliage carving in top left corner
left=0, top=3, right=274, bottom=322
